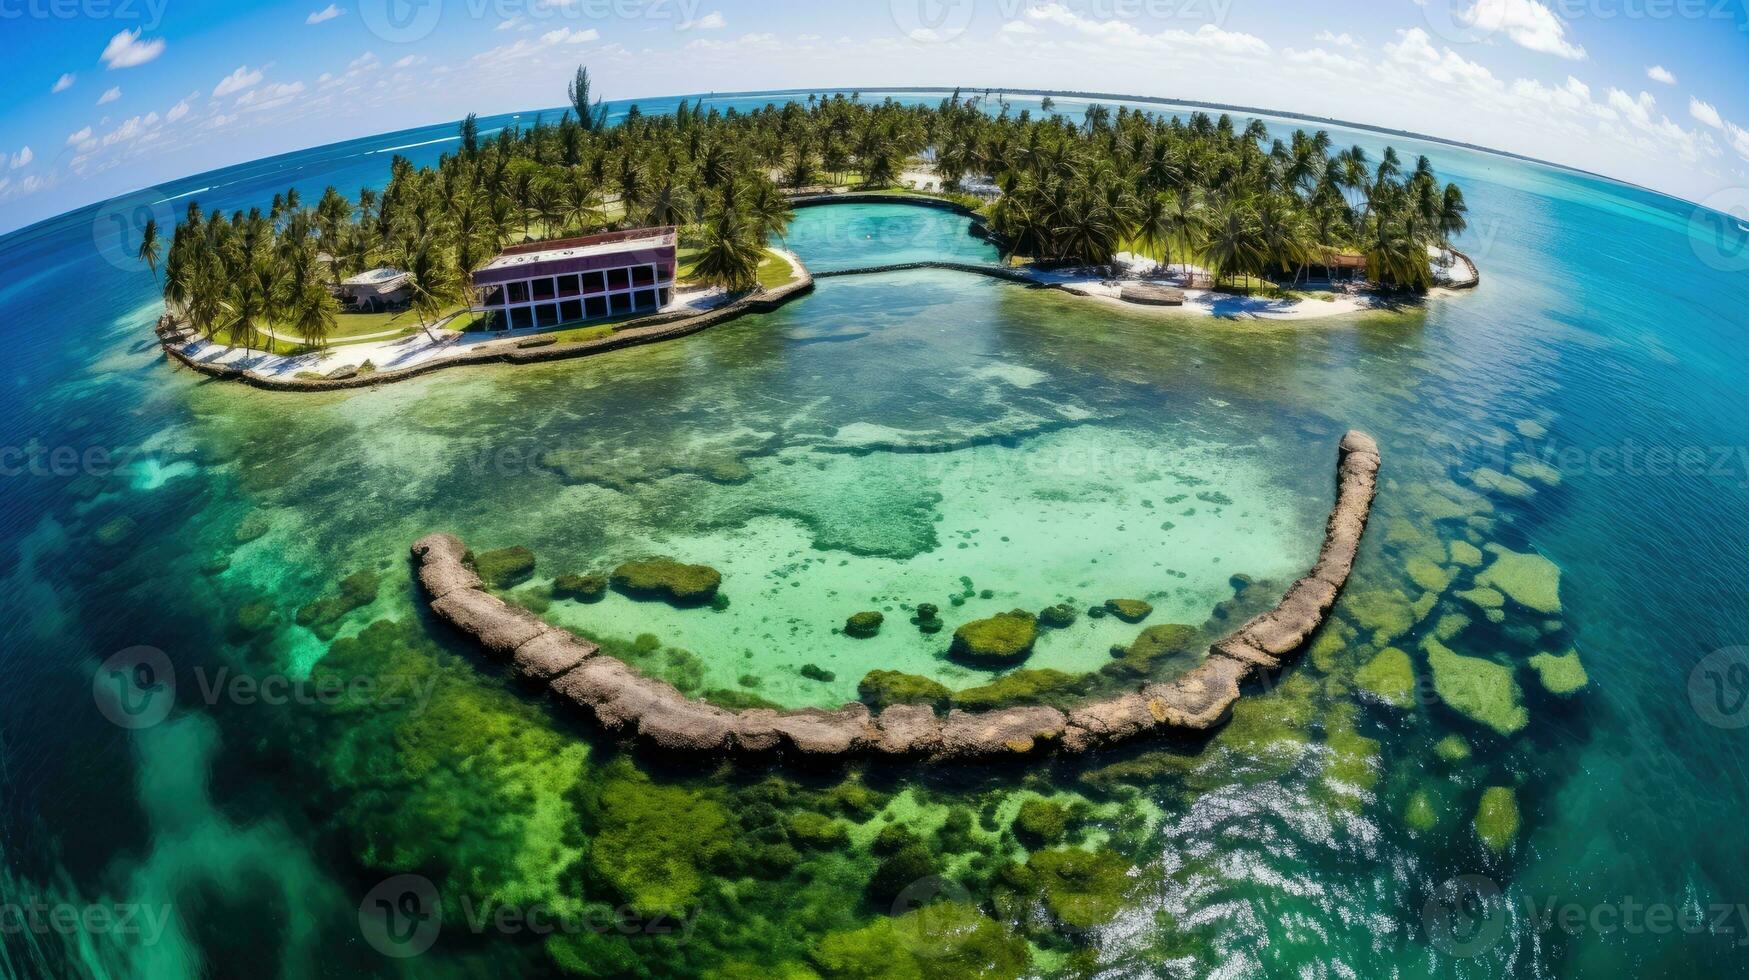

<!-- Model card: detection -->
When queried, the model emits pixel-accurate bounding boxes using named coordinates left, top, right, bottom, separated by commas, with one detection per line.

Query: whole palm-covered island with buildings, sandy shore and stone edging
left=157, top=68, right=1478, bottom=390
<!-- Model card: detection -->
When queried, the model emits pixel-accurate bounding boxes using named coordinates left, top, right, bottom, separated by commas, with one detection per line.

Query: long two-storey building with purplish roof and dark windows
left=472, top=228, right=679, bottom=331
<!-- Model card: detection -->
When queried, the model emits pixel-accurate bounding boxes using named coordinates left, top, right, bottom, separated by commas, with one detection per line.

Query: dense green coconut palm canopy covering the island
left=164, top=72, right=1466, bottom=343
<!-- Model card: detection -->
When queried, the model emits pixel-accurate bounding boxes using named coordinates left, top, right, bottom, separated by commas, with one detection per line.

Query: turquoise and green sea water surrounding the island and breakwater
left=0, top=91, right=1749, bottom=977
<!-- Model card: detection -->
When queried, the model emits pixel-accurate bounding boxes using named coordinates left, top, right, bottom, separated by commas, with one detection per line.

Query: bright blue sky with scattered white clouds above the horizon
left=0, top=0, right=1749, bottom=229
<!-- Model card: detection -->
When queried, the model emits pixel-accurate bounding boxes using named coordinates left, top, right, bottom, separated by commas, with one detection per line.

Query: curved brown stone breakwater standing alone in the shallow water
left=413, top=432, right=1380, bottom=761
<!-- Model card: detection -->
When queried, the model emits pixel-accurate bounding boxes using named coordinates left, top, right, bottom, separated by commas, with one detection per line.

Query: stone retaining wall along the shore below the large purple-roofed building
left=159, top=270, right=813, bottom=392
